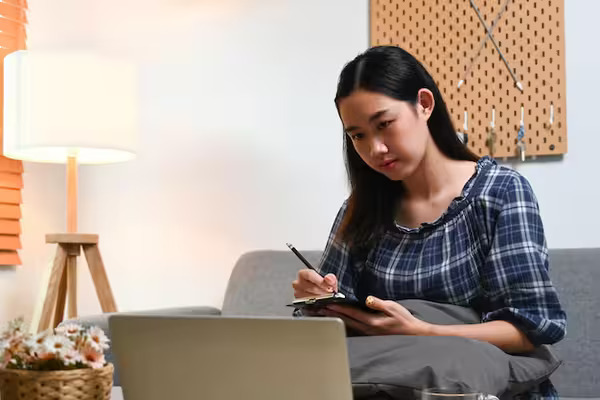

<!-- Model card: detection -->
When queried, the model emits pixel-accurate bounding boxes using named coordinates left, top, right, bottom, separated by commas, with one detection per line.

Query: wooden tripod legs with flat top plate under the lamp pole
left=38, top=233, right=117, bottom=332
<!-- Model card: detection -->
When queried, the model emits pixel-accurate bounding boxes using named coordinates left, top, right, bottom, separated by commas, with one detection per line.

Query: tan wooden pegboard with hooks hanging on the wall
left=370, top=0, right=567, bottom=157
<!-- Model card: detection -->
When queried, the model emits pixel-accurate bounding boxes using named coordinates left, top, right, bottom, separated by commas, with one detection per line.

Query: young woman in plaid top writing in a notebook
left=293, top=46, right=566, bottom=398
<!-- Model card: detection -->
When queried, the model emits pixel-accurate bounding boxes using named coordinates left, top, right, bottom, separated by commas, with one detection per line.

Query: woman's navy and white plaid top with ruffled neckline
left=318, top=157, right=566, bottom=399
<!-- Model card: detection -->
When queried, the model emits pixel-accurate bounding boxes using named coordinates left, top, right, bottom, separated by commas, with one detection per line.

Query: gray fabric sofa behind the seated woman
left=68, top=249, right=600, bottom=400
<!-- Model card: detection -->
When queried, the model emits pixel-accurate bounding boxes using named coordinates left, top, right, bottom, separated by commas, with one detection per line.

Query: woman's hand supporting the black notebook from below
left=320, top=296, right=431, bottom=336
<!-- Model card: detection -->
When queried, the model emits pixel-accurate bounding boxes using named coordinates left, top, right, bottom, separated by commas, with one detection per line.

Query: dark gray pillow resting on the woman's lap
left=348, top=300, right=560, bottom=400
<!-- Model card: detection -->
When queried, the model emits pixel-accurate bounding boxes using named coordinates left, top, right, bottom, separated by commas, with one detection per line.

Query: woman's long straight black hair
left=335, top=46, right=479, bottom=248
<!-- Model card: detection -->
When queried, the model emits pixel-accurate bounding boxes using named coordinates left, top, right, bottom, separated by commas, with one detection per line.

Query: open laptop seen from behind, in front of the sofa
left=109, top=314, right=352, bottom=400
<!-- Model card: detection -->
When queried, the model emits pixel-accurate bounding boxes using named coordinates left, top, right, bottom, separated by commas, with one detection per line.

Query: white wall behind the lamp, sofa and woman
left=0, top=0, right=600, bottom=321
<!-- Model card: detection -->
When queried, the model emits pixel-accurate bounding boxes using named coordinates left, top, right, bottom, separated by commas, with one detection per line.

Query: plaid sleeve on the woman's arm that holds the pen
left=316, top=201, right=360, bottom=299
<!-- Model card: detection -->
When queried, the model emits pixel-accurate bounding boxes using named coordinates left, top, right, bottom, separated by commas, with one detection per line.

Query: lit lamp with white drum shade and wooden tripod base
left=4, top=50, right=137, bottom=331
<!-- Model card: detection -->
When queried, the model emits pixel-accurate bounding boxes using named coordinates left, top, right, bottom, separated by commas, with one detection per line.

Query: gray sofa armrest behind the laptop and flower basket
left=60, top=306, right=221, bottom=386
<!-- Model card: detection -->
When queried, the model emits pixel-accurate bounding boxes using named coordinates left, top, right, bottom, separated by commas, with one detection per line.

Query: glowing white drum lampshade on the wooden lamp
left=3, top=50, right=138, bottom=164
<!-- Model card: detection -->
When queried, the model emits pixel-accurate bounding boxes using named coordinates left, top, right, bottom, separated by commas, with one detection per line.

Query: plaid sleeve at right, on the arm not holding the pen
left=481, top=175, right=566, bottom=345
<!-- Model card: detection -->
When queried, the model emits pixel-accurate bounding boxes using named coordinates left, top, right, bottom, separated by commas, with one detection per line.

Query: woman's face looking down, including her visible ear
left=338, top=89, right=434, bottom=180
